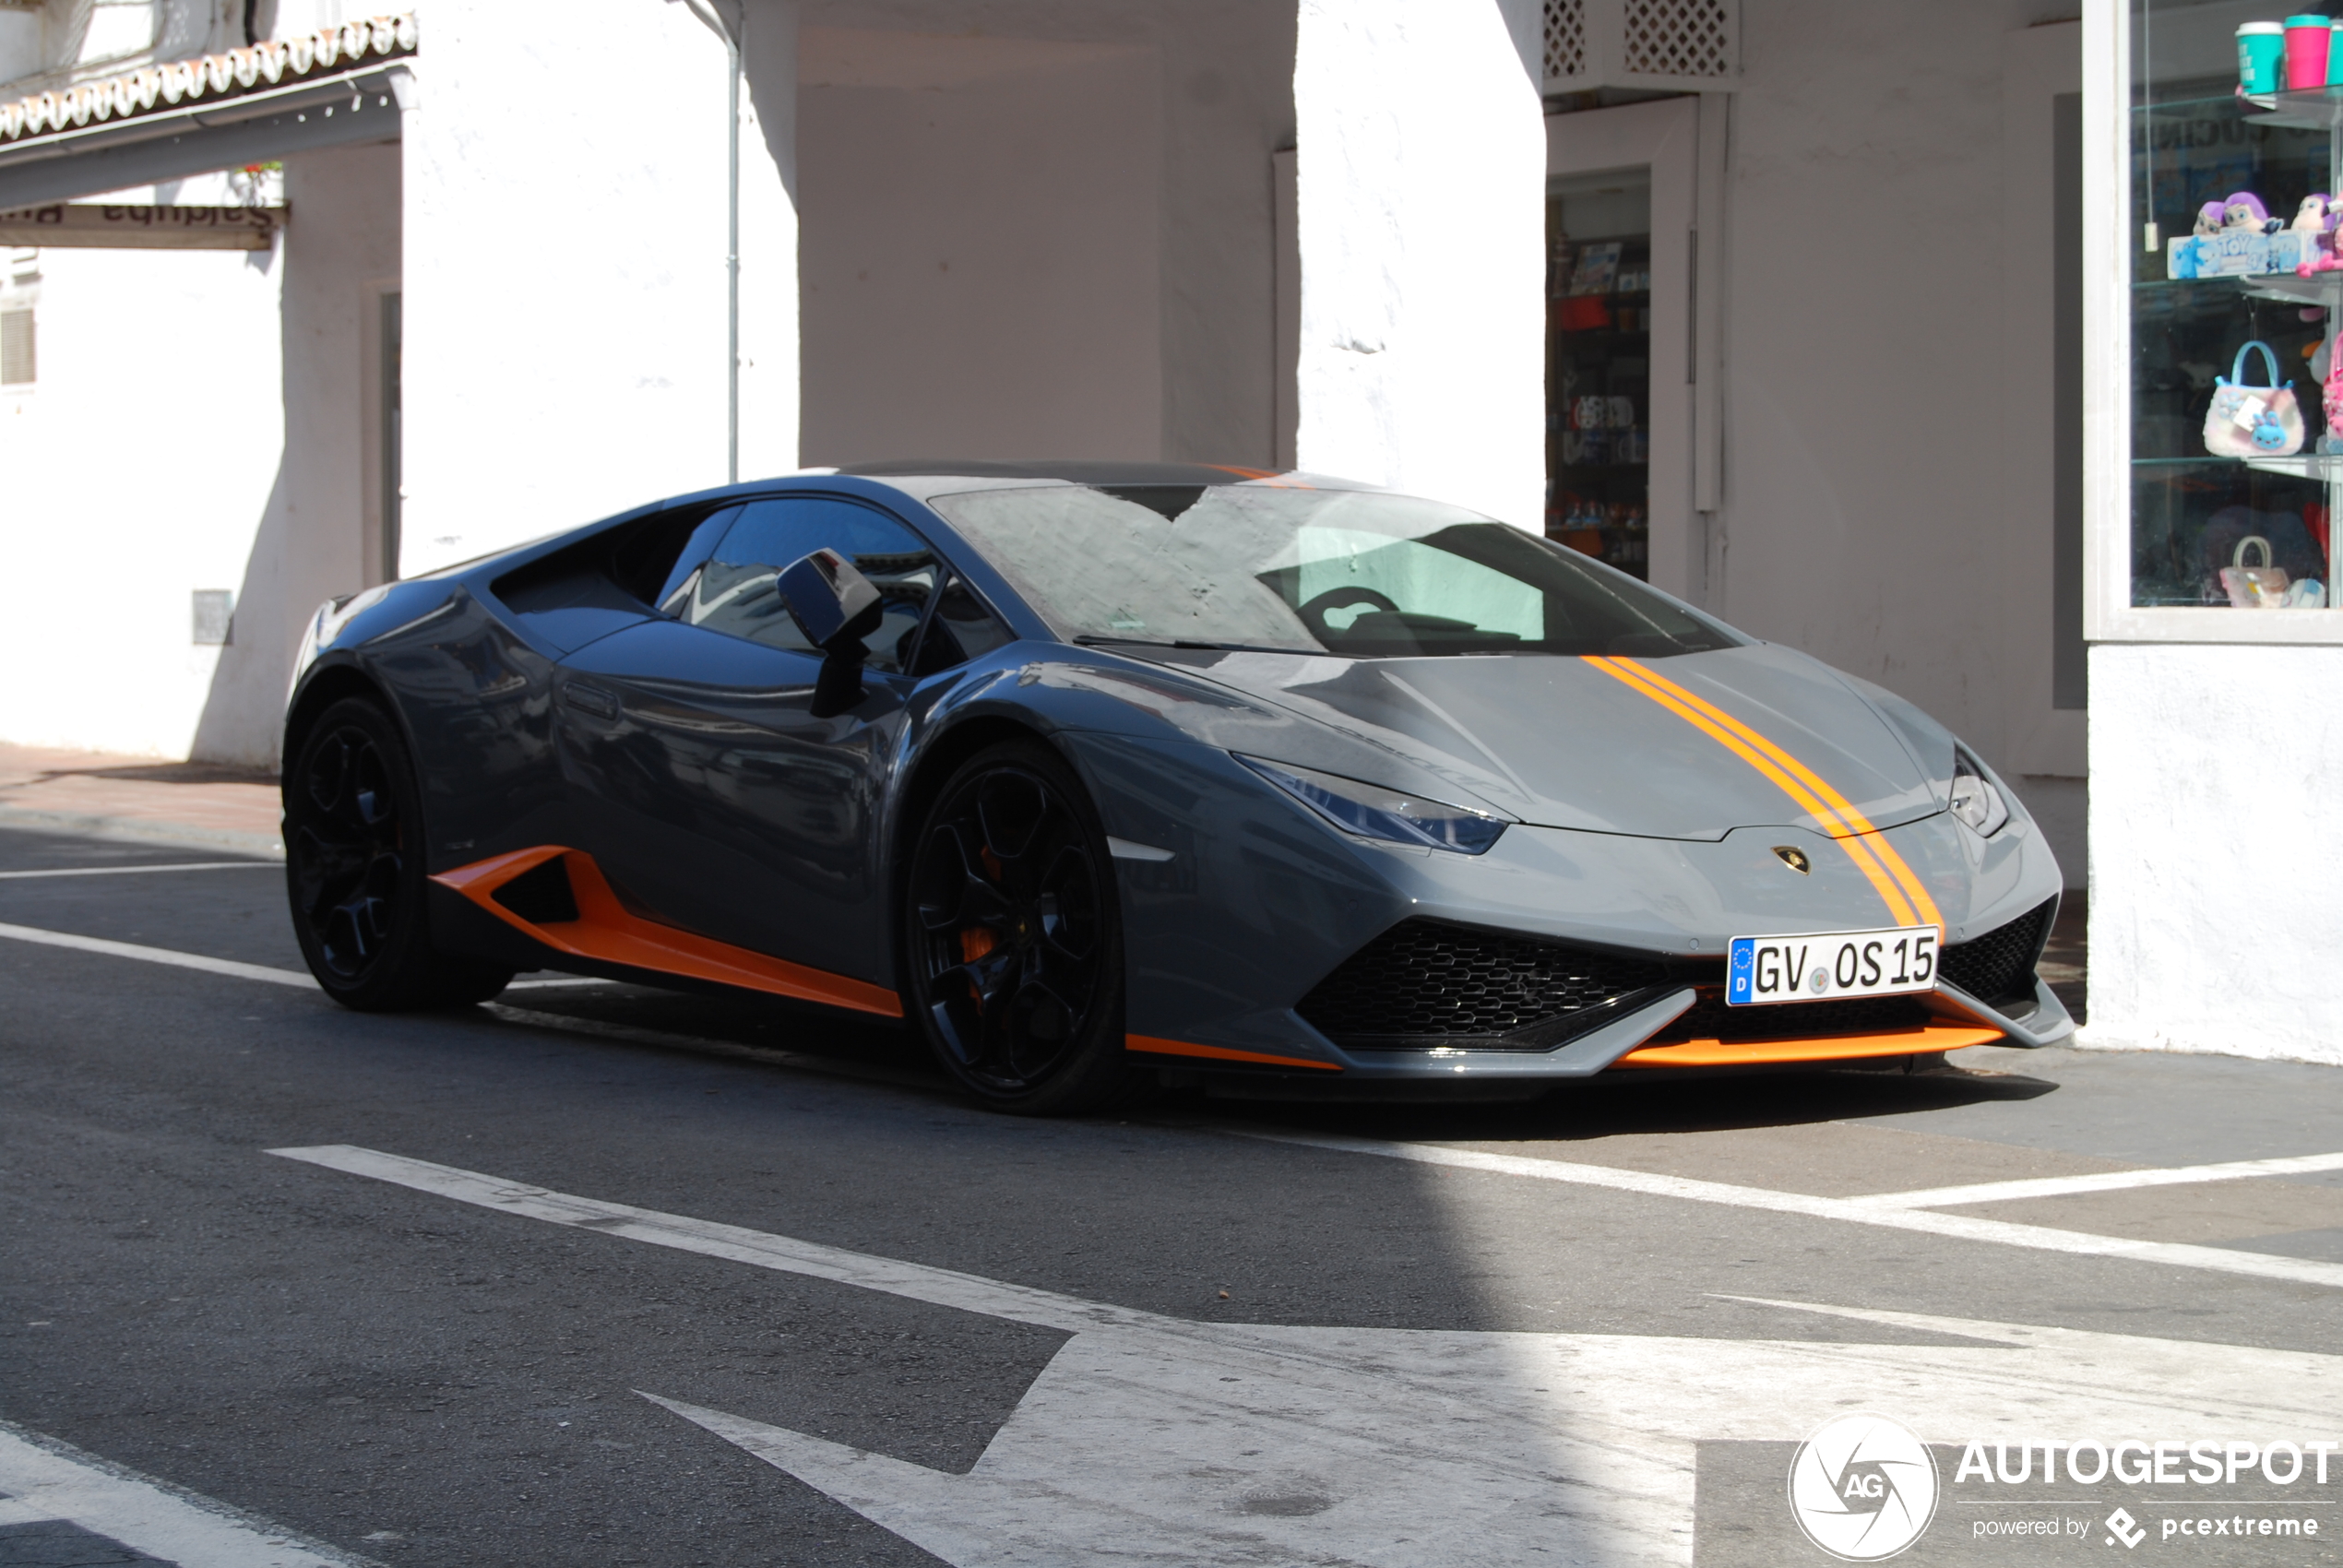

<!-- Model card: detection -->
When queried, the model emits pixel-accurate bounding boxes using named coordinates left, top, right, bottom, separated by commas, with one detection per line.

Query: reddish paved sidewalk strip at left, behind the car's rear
left=0, top=743, right=283, bottom=856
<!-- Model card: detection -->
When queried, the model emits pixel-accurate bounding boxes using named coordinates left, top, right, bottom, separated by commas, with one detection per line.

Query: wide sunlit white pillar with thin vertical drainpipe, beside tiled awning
left=400, top=0, right=797, bottom=575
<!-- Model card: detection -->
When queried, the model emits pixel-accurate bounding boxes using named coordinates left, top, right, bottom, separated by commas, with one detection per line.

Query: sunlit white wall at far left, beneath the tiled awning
left=0, top=181, right=286, bottom=757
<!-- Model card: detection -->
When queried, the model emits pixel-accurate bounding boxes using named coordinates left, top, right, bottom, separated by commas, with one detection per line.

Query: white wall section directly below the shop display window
left=2083, top=645, right=2343, bottom=1064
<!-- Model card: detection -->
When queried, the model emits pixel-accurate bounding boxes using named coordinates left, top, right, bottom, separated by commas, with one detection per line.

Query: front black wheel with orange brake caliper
left=904, top=741, right=1134, bottom=1116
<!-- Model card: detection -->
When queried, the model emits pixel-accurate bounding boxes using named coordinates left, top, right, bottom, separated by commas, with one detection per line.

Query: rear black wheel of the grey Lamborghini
left=283, top=698, right=513, bottom=1013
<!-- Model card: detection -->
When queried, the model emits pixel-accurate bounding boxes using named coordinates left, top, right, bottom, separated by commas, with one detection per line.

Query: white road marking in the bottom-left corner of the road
left=0, top=1422, right=368, bottom=1568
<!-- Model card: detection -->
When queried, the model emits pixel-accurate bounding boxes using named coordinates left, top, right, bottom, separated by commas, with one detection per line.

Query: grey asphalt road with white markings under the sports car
left=0, top=832, right=2343, bottom=1568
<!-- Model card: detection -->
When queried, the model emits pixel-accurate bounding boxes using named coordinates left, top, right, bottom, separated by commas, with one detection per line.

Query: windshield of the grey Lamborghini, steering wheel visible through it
left=930, top=485, right=1736, bottom=659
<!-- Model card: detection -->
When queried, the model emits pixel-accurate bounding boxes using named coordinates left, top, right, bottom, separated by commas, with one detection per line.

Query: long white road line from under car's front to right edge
left=1220, top=1125, right=2343, bottom=1289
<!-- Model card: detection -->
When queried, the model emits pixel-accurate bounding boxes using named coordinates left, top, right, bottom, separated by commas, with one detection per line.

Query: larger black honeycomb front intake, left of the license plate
left=1298, top=921, right=1671, bottom=1050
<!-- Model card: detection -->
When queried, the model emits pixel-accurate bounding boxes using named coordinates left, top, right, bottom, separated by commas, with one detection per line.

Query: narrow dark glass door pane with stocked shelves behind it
left=1546, top=172, right=1652, bottom=579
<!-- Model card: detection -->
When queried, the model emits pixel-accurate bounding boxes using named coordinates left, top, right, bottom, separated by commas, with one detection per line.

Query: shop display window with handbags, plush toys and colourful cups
left=2125, top=0, right=2343, bottom=610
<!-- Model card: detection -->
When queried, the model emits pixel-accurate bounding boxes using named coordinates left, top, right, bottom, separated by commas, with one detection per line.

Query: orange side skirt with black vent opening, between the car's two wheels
left=431, top=844, right=902, bottom=1017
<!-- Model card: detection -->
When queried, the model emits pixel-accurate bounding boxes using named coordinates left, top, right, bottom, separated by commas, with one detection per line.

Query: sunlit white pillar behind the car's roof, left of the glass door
left=1293, top=0, right=1546, bottom=529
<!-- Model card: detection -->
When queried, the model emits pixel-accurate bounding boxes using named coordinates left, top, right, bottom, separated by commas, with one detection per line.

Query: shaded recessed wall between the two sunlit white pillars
left=802, top=0, right=1293, bottom=467
